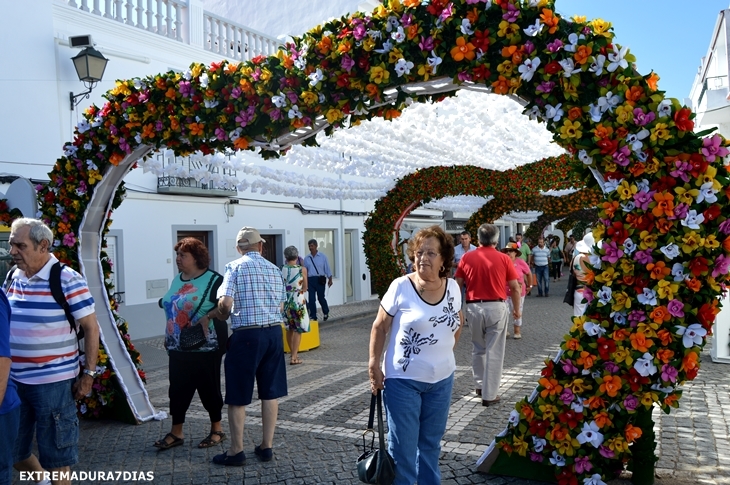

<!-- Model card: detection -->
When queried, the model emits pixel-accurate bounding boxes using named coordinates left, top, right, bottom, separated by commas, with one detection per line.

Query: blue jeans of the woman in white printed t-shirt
left=383, top=374, right=454, bottom=485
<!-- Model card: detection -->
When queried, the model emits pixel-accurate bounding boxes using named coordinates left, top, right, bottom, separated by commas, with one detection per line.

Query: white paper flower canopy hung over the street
left=136, top=87, right=563, bottom=204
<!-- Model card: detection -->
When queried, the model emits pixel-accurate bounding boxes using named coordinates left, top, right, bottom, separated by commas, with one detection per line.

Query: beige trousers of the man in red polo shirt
left=466, top=301, right=509, bottom=401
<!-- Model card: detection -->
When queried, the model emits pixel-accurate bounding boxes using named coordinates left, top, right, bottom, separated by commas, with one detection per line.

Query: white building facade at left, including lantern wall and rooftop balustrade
left=0, top=0, right=536, bottom=339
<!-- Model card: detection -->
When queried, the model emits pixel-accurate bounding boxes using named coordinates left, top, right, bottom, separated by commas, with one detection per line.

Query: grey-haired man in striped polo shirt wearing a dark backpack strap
left=4, top=218, right=99, bottom=484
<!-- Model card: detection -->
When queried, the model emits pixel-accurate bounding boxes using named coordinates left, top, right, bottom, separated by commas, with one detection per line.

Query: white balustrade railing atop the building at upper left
left=65, top=0, right=281, bottom=61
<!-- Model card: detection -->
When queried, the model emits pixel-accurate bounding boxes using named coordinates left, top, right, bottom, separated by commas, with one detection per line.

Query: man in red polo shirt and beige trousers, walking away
left=455, top=224, right=521, bottom=406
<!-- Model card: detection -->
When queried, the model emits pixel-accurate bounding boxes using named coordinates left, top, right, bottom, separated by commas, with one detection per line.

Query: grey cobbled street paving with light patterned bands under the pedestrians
left=15, top=281, right=730, bottom=485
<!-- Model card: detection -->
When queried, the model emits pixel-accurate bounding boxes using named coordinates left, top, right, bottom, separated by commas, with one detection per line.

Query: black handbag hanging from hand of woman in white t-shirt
left=357, top=389, right=395, bottom=485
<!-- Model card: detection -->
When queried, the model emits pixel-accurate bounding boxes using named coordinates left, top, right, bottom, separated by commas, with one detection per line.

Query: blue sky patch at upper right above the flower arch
left=555, top=0, right=730, bottom=101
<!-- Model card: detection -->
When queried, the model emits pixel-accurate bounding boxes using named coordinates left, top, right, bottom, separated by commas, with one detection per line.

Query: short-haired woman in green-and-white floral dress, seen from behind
left=281, top=246, right=307, bottom=365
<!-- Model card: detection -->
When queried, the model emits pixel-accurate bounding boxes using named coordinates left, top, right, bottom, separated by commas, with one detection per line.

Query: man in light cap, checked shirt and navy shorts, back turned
left=213, top=227, right=287, bottom=466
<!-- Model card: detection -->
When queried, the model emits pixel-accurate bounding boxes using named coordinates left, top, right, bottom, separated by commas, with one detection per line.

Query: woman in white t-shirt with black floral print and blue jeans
left=368, top=226, right=463, bottom=485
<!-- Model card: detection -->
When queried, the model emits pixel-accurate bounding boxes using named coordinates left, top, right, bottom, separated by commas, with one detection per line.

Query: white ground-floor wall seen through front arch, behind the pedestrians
left=112, top=187, right=372, bottom=338
